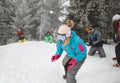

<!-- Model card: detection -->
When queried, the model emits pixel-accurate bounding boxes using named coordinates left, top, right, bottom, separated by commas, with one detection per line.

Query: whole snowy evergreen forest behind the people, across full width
left=0, top=0, right=120, bottom=45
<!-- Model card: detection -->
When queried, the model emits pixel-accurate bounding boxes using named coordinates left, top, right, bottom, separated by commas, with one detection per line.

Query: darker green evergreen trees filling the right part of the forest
left=67, top=0, right=120, bottom=42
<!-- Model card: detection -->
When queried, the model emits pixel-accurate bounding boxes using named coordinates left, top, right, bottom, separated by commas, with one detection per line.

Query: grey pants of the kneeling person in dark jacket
left=88, top=46, right=106, bottom=57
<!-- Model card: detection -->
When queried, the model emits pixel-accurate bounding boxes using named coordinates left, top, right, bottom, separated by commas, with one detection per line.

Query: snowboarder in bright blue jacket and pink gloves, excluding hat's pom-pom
left=51, top=25, right=87, bottom=83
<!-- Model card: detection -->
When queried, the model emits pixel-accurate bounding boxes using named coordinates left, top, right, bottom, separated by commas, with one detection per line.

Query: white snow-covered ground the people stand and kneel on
left=0, top=41, right=120, bottom=83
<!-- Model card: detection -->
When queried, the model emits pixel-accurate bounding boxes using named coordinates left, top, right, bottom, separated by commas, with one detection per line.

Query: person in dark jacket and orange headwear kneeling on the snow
left=85, top=27, right=106, bottom=58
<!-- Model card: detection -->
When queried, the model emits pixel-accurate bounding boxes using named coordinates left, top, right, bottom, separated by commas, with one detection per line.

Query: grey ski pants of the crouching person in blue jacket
left=62, top=55, right=86, bottom=83
